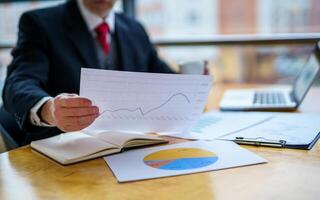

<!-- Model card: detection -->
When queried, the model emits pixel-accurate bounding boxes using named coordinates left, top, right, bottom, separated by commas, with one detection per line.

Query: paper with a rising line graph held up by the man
left=80, top=68, right=212, bottom=132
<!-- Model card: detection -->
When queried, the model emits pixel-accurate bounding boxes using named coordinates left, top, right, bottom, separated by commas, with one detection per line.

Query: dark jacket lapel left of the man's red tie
left=65, top=0, right=99, bottom=67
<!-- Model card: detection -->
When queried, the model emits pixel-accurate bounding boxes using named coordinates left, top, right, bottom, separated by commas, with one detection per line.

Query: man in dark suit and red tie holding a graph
left=3, top=0, right=172, bottom=145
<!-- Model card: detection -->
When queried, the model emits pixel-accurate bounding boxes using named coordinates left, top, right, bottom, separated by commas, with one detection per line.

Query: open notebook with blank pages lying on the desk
left=31, top=131, right=168, bottom=165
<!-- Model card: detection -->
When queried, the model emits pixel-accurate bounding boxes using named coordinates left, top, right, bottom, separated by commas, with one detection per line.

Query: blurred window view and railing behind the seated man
left=0, top=0, right=320, bottom=99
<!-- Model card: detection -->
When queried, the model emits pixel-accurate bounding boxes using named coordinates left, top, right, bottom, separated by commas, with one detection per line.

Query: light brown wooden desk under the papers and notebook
left=0, top=85, right=320, bottom=200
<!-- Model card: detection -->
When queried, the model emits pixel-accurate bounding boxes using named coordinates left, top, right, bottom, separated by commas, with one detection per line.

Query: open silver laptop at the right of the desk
left=220, top=41, right=320, bottom=111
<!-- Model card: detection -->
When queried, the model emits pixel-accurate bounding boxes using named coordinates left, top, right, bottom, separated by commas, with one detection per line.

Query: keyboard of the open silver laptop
left=253, top=91, right=286, bottom=105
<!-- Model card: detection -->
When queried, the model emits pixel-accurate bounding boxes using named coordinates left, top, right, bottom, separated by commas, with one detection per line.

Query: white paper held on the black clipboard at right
left=222, top=113, right=320, bottom=145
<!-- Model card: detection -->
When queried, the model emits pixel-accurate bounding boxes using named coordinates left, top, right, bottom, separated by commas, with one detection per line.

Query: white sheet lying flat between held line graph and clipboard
left=173, top=111, right=273, bottom=140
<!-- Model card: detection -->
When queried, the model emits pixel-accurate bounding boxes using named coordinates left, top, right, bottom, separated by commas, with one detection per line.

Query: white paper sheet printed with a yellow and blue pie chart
left=104, top=140, right=266, bottom=182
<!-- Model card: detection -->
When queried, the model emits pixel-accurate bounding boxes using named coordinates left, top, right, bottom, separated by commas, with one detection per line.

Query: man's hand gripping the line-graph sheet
left=41, top=93, right=99, bottom=132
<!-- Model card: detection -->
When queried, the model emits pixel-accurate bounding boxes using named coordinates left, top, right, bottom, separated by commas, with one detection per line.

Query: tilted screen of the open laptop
left=293, top=50, right=320, bottom=104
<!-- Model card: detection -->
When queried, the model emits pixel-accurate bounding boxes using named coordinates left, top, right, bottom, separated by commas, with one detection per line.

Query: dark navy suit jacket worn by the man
left=3, top=0, right=172, bottom=143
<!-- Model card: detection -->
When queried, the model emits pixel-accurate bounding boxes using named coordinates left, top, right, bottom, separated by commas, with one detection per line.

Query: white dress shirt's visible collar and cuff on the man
left=29, top=0, right=115, bottom=127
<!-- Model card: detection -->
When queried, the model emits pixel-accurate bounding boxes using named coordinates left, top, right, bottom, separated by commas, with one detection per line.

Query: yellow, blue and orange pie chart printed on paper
left=143, top=148, right=218, bottom=170
